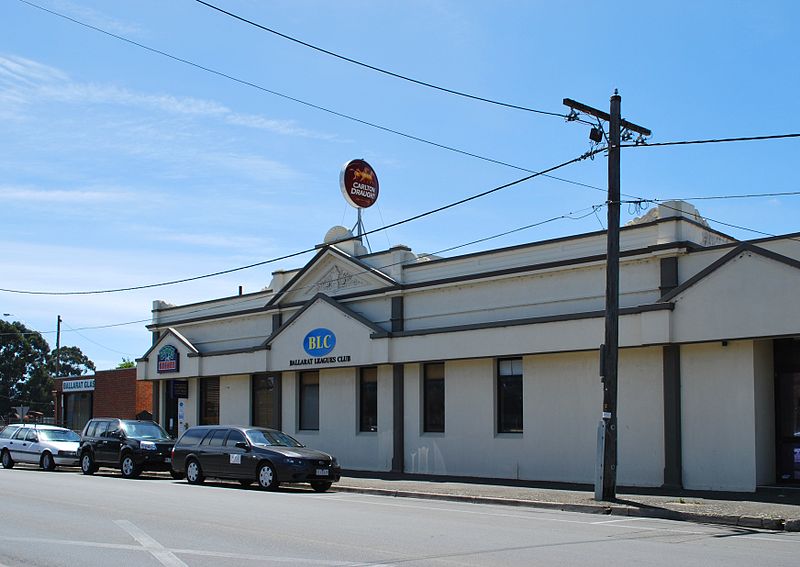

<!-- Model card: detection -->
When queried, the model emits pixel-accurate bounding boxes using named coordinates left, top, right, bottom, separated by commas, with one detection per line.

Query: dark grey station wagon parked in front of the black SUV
left=172, top=425, right=342, bottom=492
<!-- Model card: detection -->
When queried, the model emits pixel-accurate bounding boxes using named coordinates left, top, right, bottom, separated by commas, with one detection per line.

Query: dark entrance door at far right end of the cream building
left=776, top=373, right=800, bottom=482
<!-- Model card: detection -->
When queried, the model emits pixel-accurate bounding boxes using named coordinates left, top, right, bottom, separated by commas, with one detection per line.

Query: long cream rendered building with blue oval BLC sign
left=137, top=202, right=800, bottom=491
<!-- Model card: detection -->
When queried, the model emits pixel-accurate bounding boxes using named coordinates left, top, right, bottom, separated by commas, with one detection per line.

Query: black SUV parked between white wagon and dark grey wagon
left=78, top=418, right=175, bottom=478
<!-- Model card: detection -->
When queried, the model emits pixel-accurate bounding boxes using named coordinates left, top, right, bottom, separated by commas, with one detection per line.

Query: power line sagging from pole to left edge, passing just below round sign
left=0, top=149, right=605, bottom=295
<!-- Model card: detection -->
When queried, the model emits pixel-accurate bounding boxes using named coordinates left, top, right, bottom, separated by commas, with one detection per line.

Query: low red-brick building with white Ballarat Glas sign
left=55, top=368, right=153, bottom=431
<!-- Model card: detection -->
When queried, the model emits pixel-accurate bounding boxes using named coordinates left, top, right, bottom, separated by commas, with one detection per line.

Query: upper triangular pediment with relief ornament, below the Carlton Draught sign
left=269, top=246, right=397, bottom=305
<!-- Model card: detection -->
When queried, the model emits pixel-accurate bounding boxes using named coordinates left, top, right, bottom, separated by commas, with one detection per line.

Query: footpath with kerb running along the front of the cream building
left=332, top=471, right=800, bottom=532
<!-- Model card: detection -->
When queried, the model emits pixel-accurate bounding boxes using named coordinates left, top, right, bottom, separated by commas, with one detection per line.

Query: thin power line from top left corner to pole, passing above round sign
left=14, top=0, right=605, bottom=195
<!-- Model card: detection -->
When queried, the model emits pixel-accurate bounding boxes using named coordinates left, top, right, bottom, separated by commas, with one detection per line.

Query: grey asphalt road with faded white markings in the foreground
left=0, top=465, right=800, bottom=567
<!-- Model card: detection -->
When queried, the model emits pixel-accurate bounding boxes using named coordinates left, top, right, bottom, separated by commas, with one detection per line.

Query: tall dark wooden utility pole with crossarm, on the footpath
left=564, top=89, right=651, bottom=501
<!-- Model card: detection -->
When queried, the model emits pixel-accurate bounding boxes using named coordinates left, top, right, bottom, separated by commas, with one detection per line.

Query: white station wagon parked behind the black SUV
left=0, top=424, right=80, bottom=471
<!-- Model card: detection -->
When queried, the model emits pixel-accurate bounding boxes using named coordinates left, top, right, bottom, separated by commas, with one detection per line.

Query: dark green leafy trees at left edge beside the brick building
left=0, top=320, right=95, bottom=416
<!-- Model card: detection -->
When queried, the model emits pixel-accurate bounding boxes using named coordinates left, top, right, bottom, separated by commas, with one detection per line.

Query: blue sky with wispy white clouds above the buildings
left=0, top=0, right=800, bottom=369
